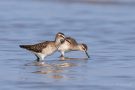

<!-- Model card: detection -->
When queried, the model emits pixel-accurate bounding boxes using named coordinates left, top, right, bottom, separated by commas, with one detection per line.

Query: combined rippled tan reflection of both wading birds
left=27, top=57, right=88, bottom=79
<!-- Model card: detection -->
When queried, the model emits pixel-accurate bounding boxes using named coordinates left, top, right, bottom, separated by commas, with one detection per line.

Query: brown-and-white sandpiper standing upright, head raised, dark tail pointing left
left=20, top=32, right=65, bottom=62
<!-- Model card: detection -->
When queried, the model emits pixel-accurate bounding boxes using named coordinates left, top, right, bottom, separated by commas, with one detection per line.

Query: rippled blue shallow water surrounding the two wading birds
left=0, top=0, right=135, bottom=90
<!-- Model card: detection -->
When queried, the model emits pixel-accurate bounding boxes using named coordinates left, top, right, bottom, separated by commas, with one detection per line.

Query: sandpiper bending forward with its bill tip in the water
left=58, top=37, right=90, bottom=58
